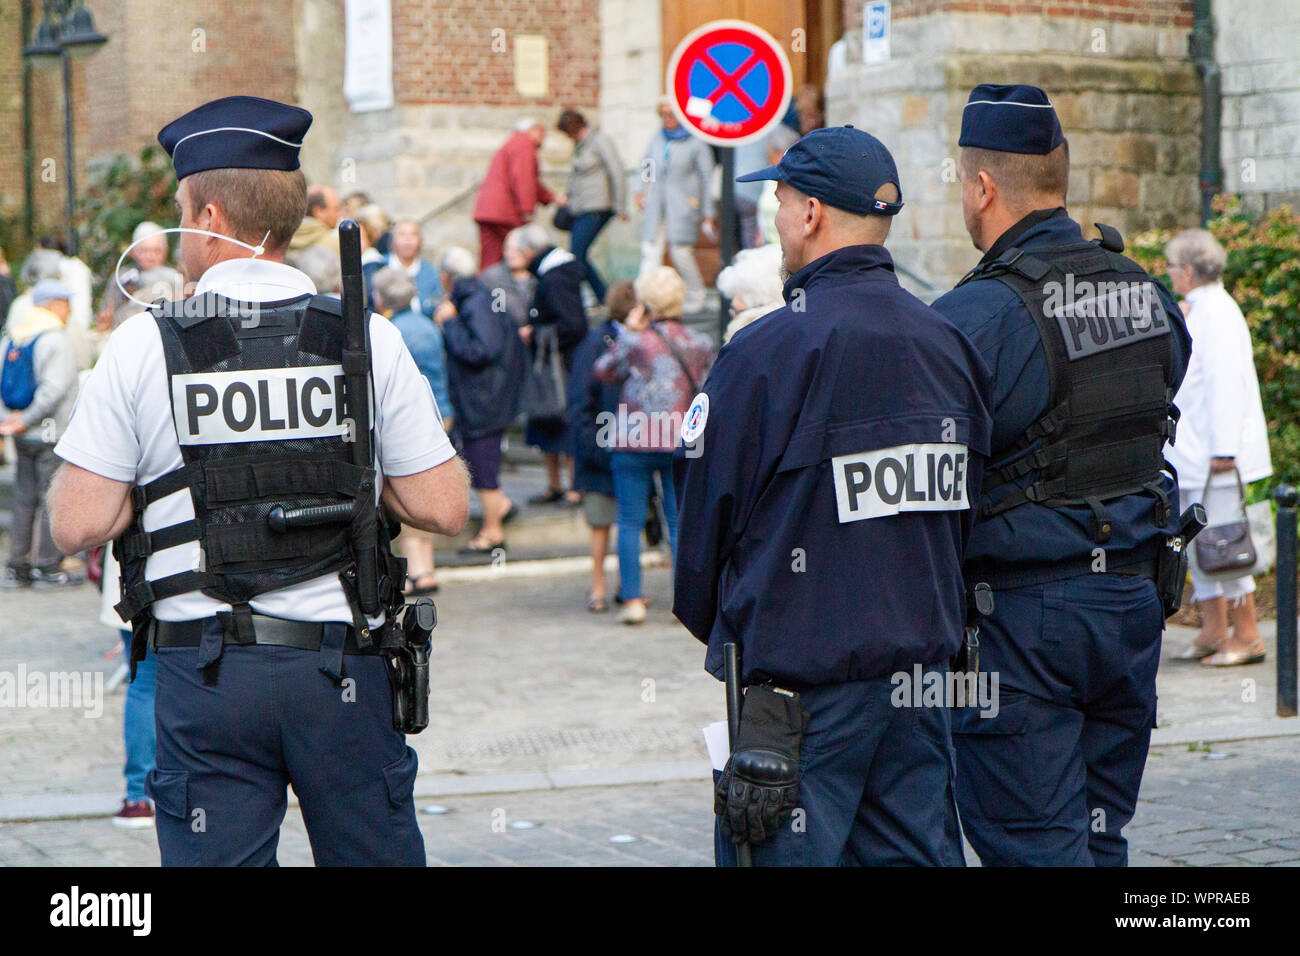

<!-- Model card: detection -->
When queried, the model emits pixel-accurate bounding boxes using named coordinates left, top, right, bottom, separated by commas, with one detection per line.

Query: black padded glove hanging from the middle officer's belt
left=714, top=687, right=809, bottom=847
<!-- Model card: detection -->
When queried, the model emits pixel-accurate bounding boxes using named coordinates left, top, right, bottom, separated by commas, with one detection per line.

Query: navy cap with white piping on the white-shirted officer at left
left=159, top=96, right=312, bottom=179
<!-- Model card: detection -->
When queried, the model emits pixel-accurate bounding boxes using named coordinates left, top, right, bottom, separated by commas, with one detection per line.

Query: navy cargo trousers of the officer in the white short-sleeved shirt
left=147, top=619, right=425, bottom=866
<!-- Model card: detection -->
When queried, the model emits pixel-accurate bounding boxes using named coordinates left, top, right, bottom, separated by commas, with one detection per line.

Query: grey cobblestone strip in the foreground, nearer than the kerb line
left=0, top=739, right=1300, bottom=866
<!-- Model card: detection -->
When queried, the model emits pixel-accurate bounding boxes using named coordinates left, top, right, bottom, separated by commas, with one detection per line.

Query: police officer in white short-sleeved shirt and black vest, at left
left=52, top=96, right=467, bottom=865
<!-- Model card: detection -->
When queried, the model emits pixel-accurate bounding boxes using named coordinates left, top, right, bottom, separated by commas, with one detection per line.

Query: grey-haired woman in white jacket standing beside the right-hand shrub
left=1165, top=229, right=1273, bottom=667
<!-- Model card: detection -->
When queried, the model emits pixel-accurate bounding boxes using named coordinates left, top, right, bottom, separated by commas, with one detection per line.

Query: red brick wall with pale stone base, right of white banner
left=332, top=0, right=602, bottom=257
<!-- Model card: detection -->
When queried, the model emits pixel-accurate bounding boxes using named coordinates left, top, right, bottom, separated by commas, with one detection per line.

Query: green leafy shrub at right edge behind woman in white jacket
left=1130, top=196, right=1300, bottom=497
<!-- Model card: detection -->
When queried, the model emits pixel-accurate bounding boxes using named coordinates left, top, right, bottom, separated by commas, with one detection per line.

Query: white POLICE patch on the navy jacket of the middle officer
left=831, top=442, right=970, bottom=524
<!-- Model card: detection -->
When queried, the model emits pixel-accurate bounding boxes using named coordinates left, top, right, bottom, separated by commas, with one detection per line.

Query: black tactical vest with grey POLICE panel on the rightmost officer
left=962, top=222, right=1179, bottom=544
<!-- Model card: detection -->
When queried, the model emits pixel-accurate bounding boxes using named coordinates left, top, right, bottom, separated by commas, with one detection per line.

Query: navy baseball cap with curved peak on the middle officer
left=736, top=126, right=902, bottom=216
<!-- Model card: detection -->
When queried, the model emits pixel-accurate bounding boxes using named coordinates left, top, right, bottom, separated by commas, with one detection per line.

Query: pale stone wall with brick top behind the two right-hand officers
left=827, top=0, right=1200, bottom=298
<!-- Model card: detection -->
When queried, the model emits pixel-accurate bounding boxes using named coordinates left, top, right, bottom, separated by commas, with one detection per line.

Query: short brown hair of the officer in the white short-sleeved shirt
left=185, top=169, right=307, bottom=252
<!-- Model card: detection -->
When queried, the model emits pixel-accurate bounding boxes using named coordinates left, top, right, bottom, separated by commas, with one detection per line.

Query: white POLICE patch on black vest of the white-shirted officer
left=172, top=365, right=351, bottom=445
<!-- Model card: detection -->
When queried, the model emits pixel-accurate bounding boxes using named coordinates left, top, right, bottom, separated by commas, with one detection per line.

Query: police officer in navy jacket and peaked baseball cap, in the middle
left=673, top=126, right=991, bottom=865
